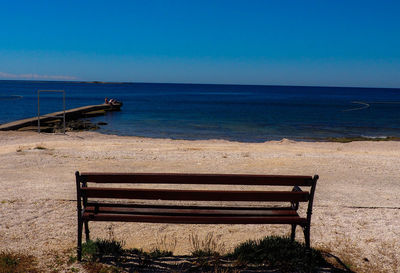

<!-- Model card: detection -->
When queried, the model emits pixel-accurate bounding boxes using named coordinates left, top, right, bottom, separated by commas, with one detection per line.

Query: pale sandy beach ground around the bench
left=0, top=131, right=400, bottom=272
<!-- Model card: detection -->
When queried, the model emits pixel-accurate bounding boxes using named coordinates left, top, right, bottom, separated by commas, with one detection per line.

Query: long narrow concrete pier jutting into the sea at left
left=0, top=104, right=120, bottom=131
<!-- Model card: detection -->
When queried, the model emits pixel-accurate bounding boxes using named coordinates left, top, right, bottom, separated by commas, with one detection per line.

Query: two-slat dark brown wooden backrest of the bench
left=76, top=172, right=318, bottom=203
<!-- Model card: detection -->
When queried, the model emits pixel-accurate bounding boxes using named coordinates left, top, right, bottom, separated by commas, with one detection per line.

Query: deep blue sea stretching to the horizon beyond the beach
left=0, top=81, right=400, bottom=142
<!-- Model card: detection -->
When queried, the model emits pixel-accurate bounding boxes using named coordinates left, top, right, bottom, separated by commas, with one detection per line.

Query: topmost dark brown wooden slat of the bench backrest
left=81, top=172, right=313, bottom=186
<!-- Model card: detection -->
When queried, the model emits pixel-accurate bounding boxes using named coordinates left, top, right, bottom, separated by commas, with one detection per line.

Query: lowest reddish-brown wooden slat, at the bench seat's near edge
left=83, top=213, right=307, bottom=224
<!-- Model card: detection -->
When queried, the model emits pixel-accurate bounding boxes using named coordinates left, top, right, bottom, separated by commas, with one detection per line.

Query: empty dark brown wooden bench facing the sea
left=75, top=172, right=318, bottom=261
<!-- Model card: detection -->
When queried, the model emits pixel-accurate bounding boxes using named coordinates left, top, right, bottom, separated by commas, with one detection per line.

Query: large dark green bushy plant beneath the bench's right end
left=228, top=236, right=327, bottom=272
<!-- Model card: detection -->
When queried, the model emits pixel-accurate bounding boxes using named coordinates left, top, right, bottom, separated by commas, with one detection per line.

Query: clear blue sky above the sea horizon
left=0, top=0, right=400, bottom=87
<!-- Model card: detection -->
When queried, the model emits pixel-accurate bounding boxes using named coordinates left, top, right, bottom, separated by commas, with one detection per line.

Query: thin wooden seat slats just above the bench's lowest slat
left=85, top=206, right=298, bottom=216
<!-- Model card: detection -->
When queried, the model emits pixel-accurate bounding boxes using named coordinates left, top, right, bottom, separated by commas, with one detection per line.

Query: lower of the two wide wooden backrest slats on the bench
left=81, top=187, right=309, bottom=202
